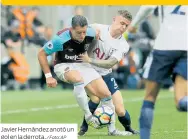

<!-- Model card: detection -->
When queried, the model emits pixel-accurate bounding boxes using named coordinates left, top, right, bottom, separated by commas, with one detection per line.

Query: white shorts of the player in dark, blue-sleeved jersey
left=54, top=63, right=101, bottom=86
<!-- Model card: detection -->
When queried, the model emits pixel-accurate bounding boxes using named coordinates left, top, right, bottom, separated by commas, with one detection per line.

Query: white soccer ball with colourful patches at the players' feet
left=93, top=106, right=114, bottom=127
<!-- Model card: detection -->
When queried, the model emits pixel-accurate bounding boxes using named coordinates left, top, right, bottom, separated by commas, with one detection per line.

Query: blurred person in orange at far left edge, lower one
left=1, top=26, right=29, bottom=91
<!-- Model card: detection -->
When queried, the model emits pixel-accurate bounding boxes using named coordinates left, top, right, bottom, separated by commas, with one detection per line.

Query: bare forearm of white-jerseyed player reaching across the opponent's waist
left=78, top=53, right=118, bottom=69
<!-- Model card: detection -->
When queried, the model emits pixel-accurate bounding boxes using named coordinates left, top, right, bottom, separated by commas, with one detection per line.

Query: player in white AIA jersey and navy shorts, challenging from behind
left=78, top=10, right=137, bottom=136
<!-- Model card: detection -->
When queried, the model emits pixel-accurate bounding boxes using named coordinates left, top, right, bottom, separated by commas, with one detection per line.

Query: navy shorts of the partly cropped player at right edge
left=143, top=50, right=187, bottom=83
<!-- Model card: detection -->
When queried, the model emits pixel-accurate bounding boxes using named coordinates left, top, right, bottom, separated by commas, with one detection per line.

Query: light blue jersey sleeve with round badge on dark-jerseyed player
left=43, top=35, right=63, bottom=55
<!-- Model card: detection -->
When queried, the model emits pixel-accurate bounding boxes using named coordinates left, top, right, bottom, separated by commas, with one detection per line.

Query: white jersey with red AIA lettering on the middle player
left=88, top=24, right=129, bottom=76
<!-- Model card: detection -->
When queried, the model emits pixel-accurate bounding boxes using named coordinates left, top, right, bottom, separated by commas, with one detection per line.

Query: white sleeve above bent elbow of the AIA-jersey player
left=111, top=42, right=129, bottom=62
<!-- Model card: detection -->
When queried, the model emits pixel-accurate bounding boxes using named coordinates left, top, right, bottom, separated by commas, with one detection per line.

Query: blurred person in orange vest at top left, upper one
left=7, top=7, right=44, bottom=45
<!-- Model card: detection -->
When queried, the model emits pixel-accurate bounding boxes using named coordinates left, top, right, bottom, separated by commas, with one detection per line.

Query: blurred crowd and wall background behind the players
left=1, top=5, right=171, bottom=91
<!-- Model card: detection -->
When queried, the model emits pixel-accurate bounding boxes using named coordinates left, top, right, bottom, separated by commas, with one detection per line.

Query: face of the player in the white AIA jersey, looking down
left=113, top=15, right=131, bottom=34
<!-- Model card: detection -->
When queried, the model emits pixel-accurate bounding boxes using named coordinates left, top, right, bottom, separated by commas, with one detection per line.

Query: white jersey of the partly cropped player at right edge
left=132, top=5, right=188, bottom=51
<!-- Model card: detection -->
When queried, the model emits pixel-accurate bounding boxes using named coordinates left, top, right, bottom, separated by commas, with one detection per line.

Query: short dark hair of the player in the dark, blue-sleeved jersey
left=72, top=15, right=88, bottom=28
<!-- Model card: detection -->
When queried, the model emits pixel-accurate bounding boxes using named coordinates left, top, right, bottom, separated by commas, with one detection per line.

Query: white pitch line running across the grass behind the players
left=0, top=95, right=173, bottom=115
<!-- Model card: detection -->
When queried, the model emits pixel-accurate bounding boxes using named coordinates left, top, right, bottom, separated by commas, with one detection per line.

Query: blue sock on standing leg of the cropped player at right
left=139, top=100, right=154, bottom=139
